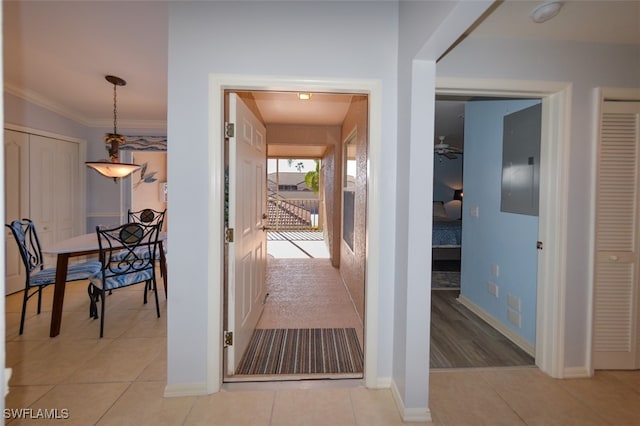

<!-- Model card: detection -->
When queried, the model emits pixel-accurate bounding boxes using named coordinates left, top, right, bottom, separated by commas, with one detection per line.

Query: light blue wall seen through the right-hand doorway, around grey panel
left=461, top=100, right=540, bottom=346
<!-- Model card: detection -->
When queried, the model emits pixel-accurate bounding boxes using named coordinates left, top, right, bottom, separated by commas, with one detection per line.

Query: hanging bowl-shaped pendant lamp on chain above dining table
left=85, top=75, right=140, bottom=182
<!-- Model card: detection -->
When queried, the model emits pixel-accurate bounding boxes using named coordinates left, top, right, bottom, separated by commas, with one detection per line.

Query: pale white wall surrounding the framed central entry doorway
left=167, top=2, right=397, bottom=388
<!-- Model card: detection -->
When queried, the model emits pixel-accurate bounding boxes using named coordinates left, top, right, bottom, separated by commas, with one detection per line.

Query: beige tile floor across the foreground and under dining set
left=5, top=268, right=640, bottom=426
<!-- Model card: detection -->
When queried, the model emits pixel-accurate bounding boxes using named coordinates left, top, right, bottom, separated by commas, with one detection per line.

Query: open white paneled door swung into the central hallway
left=226, top=93, right=267, bottom=375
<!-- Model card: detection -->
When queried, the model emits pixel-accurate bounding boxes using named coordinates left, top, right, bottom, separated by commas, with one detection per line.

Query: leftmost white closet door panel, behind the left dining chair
left=4, top=130, right=29, bottom=294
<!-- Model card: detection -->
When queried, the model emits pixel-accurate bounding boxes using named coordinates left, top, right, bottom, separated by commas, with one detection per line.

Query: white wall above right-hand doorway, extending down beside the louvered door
left=438, top=38, right=640, bottom=369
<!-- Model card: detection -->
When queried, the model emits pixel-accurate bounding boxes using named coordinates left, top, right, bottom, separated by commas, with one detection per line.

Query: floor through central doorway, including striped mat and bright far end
left=226, top=231, right=364, bottom=382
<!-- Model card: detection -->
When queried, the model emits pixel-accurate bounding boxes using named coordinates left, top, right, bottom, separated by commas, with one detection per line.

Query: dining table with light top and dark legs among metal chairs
left=42, top=231, right=167, bottom=337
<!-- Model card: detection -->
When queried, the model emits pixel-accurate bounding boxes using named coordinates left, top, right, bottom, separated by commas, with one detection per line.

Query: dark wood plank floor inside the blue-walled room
left=430, top=290, right=534, bottom=368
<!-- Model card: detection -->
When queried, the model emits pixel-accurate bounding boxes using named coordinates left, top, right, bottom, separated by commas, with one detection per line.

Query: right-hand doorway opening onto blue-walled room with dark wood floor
left=431, top=97, right=541, bottom=368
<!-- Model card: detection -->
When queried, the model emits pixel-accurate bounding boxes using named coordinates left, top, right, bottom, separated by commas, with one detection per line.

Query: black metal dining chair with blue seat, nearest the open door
left=88, top=223, right=161, bottom=337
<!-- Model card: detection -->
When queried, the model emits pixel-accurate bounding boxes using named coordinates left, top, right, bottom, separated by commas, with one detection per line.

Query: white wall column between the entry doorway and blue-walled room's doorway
left=392, top=1, right=491, bottom=421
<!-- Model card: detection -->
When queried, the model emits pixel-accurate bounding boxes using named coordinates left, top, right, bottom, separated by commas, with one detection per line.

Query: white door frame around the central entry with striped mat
left=207, top=74, right=382, bottom=392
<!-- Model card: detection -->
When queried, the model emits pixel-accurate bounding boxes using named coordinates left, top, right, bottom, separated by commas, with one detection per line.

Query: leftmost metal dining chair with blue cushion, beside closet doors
left=5, top=219, right=101, bottom=334
